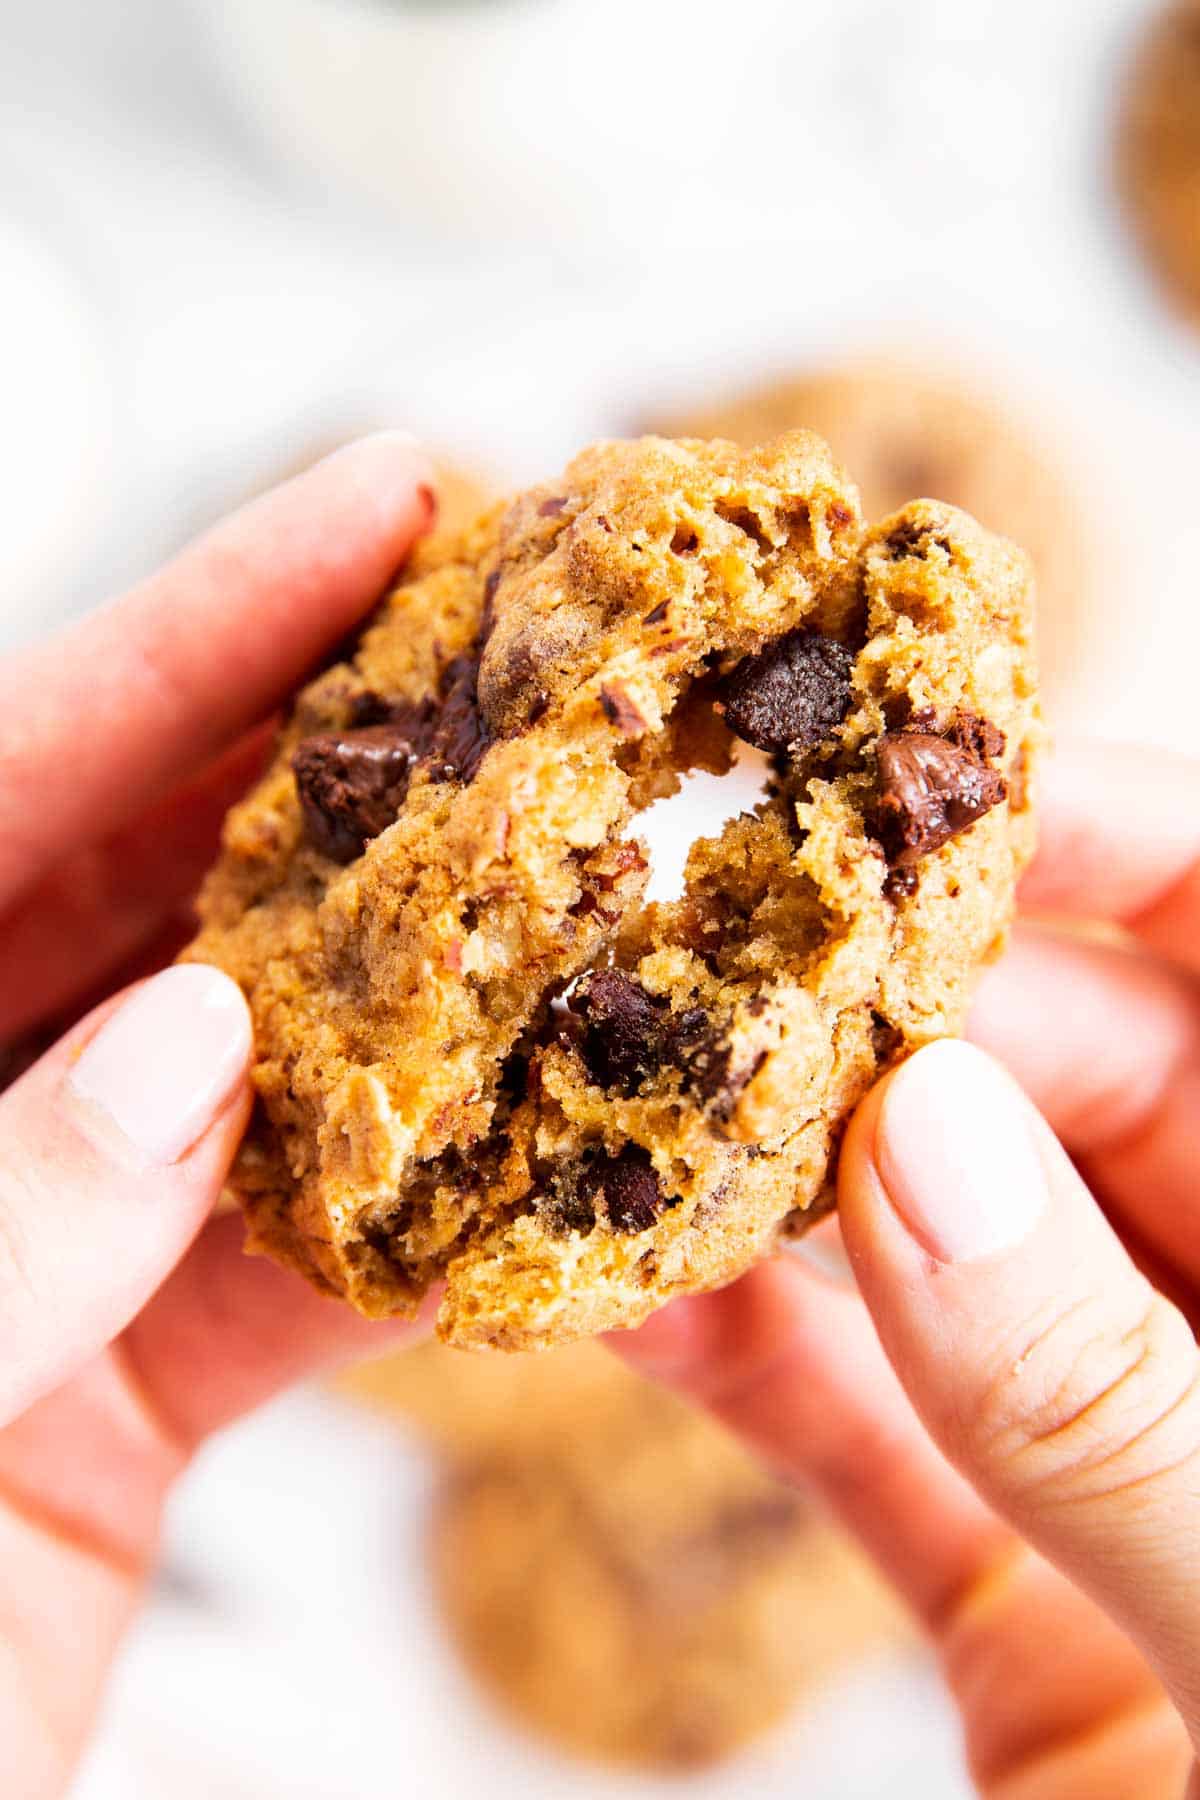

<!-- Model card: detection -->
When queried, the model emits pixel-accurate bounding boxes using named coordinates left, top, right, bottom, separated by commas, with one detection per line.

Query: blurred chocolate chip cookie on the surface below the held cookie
left=434, top=1396, right=896, bottom=1771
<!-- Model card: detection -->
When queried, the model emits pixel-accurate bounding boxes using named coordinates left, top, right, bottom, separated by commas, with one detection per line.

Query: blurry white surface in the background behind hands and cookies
left=0, top=0, right=1200, bottom=1800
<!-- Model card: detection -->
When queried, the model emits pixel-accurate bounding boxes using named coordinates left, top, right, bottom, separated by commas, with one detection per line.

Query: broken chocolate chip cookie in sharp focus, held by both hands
left=189, top=432, right=1038, bottom=1348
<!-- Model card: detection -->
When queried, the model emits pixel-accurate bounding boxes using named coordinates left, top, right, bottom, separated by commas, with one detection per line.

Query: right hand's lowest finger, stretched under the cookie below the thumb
left=610, top=1262, right=1180, bottom=1800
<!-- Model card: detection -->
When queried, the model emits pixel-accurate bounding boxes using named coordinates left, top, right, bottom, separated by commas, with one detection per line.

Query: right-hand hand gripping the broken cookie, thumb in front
left=615, top=745, right=1200, bottom=1800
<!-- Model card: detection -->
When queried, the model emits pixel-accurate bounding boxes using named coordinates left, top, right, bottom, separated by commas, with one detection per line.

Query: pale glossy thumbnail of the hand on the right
left=874, top=1039, right=1047, bottom=1262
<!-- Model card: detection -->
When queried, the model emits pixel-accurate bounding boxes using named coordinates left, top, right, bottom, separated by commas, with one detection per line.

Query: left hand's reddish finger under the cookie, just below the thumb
left=122, top=1217, right=437, bottom=1447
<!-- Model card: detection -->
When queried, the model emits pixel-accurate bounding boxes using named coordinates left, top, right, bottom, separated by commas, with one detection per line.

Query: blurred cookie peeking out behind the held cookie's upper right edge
left=642, top=358, right=1096, bottom=709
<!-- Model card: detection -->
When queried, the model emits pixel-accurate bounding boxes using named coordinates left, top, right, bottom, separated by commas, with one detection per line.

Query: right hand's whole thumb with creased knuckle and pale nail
left=840, top=1040, right=1200, bottom=1739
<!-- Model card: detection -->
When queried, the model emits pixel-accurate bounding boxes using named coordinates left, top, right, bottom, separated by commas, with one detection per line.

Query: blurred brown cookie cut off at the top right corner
left=1117, top=0, right=1200, bottom=322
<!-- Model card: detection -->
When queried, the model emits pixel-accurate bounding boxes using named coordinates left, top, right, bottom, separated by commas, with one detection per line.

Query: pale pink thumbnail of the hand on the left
left=67, top=963, right=250, bottom=1165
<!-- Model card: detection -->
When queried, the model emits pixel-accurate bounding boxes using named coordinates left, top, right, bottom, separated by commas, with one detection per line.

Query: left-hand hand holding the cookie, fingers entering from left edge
left=0, top=436, right=434, bottom=1800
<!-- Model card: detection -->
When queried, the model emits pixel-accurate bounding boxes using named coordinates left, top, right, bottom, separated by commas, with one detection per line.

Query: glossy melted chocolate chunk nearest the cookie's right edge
left=874, top=731, right=1006, bottom=869
